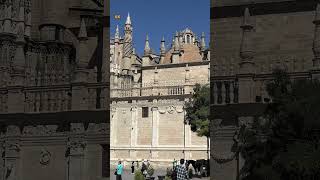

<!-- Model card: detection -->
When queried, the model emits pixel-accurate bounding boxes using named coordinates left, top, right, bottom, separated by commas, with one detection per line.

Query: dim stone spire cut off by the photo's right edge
left=312, top=3, right=320, bottom=69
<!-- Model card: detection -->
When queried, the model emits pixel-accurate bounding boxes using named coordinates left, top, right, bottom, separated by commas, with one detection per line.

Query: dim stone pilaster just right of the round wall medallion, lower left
left=68, top=123, right=86, bottom=180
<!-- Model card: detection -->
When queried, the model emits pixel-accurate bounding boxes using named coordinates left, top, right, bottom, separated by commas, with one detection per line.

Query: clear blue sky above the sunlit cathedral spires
left=110, top=0, right=210, bottom=55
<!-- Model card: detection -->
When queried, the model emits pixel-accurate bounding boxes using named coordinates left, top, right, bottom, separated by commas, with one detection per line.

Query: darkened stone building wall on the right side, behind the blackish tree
left=210, top=0, right=320, bottom=180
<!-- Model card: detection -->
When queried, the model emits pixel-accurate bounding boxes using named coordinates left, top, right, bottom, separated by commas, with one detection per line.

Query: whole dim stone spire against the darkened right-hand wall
left=240, top=8, right=254, bottom=73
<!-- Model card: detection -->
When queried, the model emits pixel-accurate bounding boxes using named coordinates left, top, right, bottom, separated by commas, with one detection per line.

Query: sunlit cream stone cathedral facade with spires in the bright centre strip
left=110, top=15, right=210, bottom=168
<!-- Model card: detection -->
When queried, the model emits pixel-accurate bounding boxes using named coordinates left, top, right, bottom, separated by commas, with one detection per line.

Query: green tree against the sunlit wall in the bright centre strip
left=186, top=84, right=210, bottom=137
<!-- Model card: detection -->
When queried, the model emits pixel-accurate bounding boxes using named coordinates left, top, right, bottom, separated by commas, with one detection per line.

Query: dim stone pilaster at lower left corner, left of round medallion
left=4, top=126, right=21, bottom=180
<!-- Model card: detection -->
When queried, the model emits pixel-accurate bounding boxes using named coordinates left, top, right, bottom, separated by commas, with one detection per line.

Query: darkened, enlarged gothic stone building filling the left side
left=0, top=0, right=109, bottom=180
